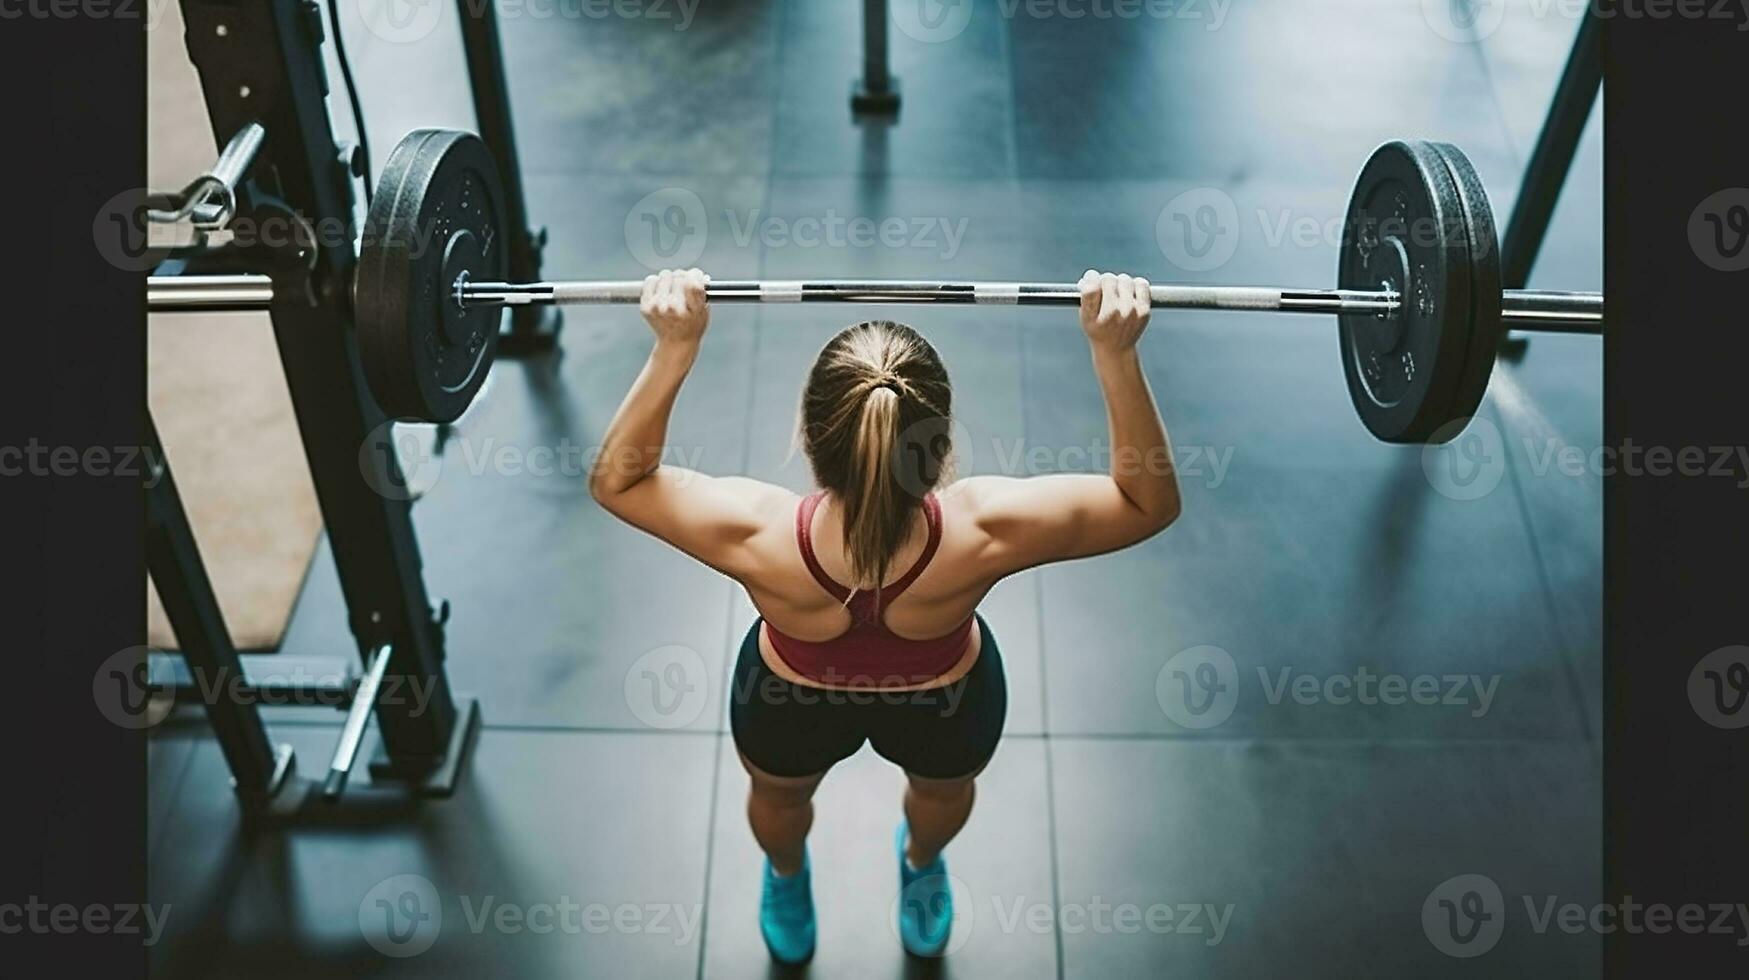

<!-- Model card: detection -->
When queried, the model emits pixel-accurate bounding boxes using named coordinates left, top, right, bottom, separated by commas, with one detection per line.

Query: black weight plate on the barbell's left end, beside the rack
left=353, top=130, right=505, bottom=422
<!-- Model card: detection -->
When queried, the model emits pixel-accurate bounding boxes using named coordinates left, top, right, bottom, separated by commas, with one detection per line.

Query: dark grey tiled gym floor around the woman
left=150, top=0, right=1602, bottom=978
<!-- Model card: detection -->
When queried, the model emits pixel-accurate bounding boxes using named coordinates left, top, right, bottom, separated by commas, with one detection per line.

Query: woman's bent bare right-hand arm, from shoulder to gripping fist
left=962, top=270, right=1181, bottom=574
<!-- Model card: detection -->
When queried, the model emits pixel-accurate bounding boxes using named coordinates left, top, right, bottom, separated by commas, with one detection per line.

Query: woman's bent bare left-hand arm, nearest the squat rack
left=589, top=270, right=789, bottom=576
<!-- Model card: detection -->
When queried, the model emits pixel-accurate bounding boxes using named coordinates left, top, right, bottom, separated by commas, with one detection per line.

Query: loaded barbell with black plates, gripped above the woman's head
left=147, top=130, right=1604, bottom=443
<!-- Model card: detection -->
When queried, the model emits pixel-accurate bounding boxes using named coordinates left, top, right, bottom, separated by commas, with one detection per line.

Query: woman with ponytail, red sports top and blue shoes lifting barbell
left=589, top=270, right=1179, bottom=963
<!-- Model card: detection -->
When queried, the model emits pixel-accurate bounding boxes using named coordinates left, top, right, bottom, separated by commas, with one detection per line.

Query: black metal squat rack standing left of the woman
left=145, top=0, right=560, bottom=814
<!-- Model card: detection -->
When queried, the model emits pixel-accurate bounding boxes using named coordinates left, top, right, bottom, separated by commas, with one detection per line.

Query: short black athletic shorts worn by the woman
left=729, top=616, right=1007, bottom=779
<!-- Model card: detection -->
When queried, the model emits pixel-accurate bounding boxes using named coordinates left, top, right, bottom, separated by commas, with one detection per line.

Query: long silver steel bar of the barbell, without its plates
left=147, top=275, right=1604, bottom=334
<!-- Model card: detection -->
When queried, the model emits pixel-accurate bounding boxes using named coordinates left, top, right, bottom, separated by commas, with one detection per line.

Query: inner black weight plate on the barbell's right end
left=1336, top=142, right=1469, bottom=443
